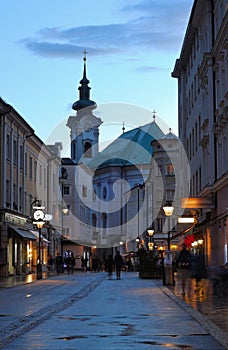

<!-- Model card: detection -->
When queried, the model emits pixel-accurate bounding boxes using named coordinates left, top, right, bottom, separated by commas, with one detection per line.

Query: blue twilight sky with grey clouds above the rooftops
left=0, top=0, right=193, bottom=152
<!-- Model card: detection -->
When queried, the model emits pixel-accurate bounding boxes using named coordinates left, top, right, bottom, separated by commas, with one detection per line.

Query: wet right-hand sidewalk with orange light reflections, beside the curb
left=170, top=273, right=228, bottom=334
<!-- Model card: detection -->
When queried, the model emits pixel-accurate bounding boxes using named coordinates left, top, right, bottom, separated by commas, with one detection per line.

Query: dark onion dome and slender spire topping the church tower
left=72, top=51, right=97, bottom=111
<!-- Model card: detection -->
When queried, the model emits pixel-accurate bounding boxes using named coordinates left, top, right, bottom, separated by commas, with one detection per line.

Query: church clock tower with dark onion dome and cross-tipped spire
left=67, top=51, right=102, bottom=164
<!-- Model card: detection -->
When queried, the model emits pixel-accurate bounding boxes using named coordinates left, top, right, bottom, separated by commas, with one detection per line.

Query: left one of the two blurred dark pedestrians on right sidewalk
left=177, top=244, right=192, bottom=296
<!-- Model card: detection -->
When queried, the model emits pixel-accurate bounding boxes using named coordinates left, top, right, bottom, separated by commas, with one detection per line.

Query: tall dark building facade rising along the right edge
left=172, top=0, right=228, bottom=264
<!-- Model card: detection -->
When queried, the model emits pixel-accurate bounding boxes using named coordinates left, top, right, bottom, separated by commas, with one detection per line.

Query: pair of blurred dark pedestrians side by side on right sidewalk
left=176, top=244, right=207, bottom=295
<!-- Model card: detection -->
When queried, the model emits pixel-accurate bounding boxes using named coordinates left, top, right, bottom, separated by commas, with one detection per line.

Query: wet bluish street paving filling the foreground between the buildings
left=0, top=272, right=228, bottom=350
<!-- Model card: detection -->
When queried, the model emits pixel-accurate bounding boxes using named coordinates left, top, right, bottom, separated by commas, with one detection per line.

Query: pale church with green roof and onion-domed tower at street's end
left=62, top=52, right=183, bottom=266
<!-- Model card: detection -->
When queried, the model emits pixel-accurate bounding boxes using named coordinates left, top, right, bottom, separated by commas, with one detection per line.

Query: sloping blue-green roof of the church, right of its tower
left=88, top=121, right=164, bottom=169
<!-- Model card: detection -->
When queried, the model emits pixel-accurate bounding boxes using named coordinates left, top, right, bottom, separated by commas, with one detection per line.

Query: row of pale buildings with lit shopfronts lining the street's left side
left=0, top=99, right=61, bottom=277
